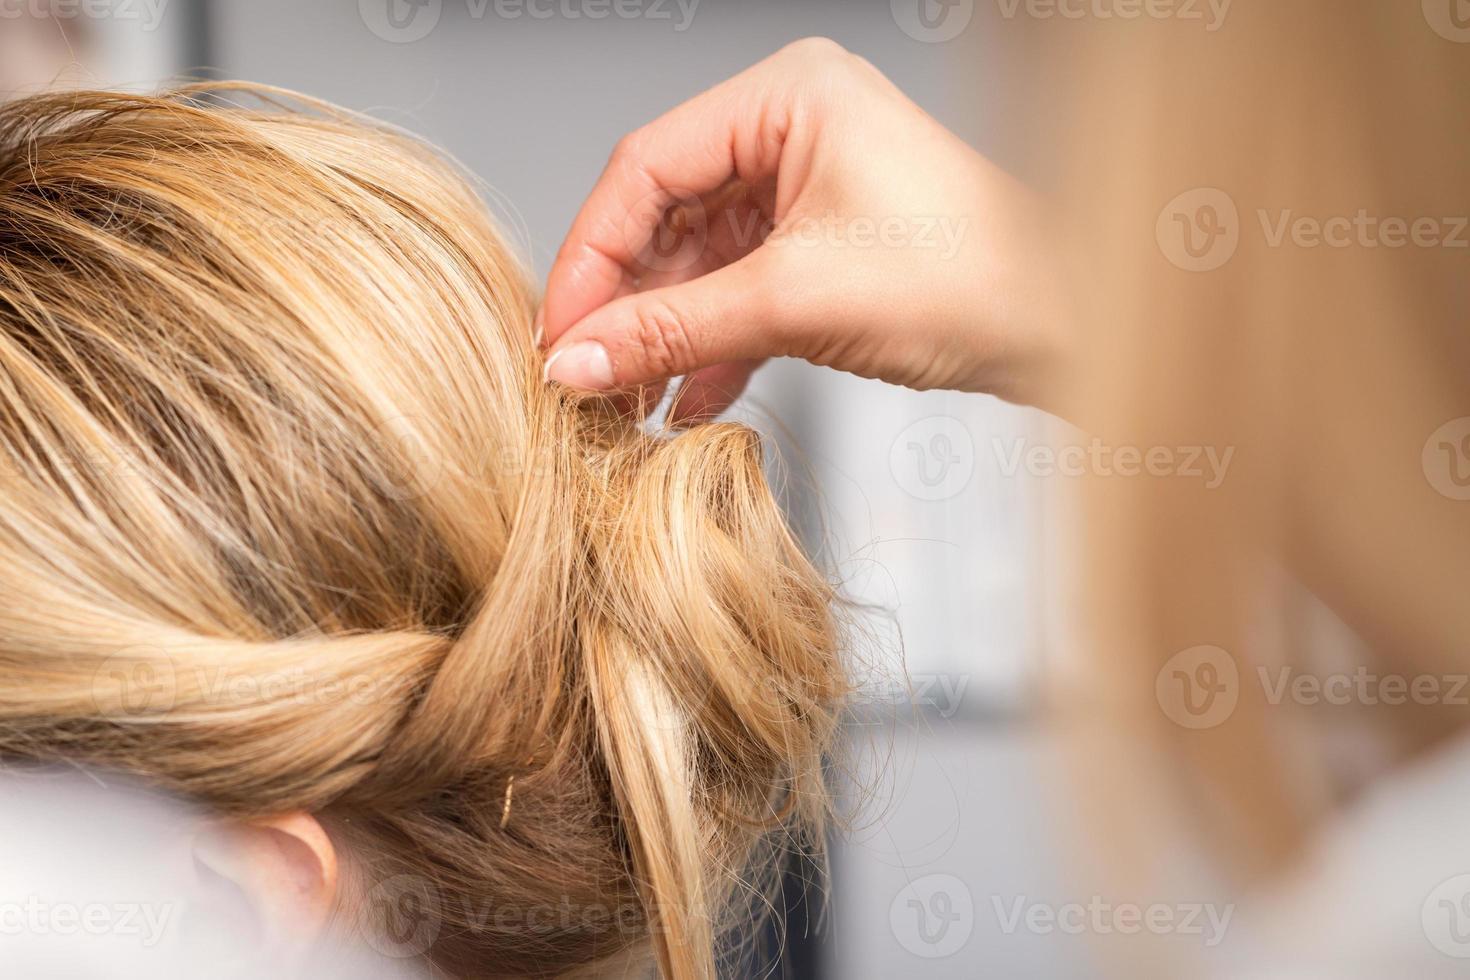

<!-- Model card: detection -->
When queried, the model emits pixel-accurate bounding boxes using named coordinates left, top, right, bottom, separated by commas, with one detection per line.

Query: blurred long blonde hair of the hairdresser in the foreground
left=998, top=0, right=1470, bottom=977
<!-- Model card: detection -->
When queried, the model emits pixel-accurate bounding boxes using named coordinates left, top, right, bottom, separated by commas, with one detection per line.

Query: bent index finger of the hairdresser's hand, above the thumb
left=541, top=63, right=789, bottom=345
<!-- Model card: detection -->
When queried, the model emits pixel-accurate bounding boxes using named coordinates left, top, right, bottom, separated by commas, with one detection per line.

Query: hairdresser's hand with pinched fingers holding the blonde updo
left=541, top=40, right=1063, bottom=422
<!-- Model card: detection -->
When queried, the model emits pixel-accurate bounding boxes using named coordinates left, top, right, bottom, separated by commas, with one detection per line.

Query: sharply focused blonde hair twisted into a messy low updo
left=0, top=90, right=842, bottom=977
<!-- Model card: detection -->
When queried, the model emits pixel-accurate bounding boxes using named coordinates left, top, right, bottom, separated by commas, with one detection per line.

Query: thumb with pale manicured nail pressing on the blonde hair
left=545, top=253, right=784, bottom=391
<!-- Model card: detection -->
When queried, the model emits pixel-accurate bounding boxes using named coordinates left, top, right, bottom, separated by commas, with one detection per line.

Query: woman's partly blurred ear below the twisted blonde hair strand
left=194, top=813, right=337, bottom=946
